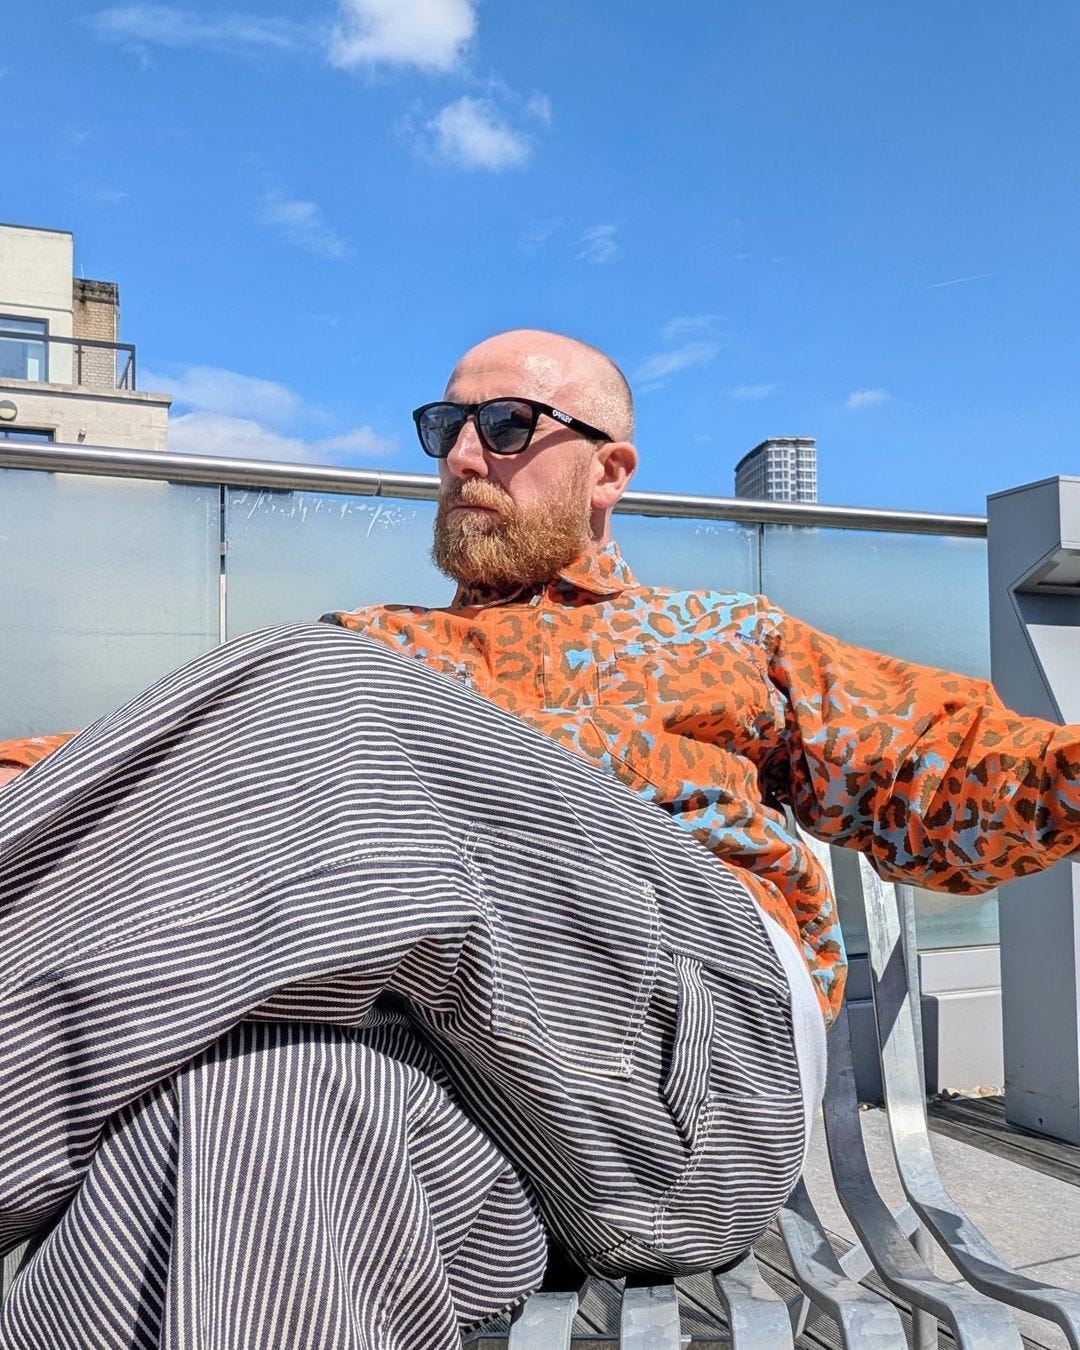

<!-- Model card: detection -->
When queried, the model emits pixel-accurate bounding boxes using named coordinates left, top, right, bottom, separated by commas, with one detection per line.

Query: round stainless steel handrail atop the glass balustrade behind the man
left=0, top=441, right=987, bottom=539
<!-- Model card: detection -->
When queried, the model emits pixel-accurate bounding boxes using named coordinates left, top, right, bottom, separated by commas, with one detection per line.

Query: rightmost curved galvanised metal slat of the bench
left=863, top=859, right=1080, bottom=1350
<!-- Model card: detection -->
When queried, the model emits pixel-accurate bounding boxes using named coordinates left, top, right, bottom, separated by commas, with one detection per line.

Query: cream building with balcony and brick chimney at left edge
left=0, top=225, right=171, bottom=450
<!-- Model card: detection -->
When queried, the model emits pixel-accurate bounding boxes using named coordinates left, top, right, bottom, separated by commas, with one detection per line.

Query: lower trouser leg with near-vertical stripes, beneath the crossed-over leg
left=0, top=1022, right=547, bottom=1350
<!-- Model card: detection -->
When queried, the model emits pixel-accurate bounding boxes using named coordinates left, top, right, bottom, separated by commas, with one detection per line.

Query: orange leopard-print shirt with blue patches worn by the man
left=0, top=545, right=1080, bottom=1018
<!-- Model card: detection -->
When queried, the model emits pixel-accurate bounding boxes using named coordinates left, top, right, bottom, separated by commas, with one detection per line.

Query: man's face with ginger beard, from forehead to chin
left=432, top=339, right=594, bottom=591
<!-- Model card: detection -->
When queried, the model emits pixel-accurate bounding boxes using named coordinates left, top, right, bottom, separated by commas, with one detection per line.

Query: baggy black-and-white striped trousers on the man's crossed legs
left=0, top=625, right=824, bottom=1350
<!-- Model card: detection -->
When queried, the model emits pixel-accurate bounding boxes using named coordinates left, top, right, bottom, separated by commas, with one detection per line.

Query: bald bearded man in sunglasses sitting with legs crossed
left=0, top=331, right=1080, bottom=1350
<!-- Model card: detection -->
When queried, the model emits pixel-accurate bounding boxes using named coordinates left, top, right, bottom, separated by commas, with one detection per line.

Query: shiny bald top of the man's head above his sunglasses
left=447, top=328, right=633, bottom=440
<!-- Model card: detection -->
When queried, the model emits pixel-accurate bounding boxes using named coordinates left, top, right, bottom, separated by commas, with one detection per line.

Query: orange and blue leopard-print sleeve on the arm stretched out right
left=763, top=610, right=1080, bottom=895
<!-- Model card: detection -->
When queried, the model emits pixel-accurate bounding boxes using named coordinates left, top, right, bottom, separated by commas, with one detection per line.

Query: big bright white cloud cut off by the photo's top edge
left=328, top=0, right=477, bottom=70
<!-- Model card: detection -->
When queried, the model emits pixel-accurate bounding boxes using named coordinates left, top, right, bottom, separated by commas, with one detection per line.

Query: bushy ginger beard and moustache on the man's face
left=431, top=455, right=591, bottom=593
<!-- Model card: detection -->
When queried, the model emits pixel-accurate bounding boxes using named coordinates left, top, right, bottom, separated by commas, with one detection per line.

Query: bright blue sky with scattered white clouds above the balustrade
left=8, top=0, right=1080, bottom=512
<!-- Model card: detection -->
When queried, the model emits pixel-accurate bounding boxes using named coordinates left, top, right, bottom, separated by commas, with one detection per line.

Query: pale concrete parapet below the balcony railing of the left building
left=0, top=379, right=171, bottom=450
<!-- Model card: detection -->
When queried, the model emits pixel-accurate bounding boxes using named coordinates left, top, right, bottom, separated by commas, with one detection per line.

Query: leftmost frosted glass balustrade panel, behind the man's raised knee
left=0, top=468, right=220, bottom=740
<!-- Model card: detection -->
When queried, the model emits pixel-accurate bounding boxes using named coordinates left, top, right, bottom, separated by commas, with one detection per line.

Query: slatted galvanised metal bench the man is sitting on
left=496, top=838, right=1080, bottom=1350
